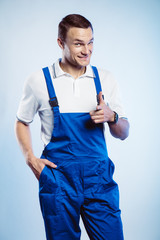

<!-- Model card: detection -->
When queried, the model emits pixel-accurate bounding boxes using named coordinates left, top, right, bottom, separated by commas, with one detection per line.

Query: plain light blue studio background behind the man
left=0, top=0, right=160, bottom=240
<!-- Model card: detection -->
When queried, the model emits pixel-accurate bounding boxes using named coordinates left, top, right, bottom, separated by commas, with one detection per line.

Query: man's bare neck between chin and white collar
left=60, top=59, right=86, bottom=79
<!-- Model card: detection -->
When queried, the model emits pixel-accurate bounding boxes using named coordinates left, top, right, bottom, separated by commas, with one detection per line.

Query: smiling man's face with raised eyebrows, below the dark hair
left=58, top=27, right=93, bottom=68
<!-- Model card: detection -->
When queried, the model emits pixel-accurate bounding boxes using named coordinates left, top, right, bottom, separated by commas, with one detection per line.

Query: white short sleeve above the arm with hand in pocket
left=17, top=79, right=38, bottom=124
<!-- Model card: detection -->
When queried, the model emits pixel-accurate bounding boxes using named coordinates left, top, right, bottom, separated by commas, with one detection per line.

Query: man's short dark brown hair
left=58, top=14, right=93, bottom=41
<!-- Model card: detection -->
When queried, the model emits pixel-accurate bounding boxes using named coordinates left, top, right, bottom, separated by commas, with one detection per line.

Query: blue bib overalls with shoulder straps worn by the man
left=39, top=67, right=123, bottom=240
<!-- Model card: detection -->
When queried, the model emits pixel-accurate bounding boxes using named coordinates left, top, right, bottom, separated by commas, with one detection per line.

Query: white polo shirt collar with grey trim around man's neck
left=53, top=59, right=95, bottom=78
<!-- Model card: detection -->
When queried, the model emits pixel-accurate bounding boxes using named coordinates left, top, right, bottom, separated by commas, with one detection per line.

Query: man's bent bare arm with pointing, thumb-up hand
left=90, top=92, right=129, bottom=140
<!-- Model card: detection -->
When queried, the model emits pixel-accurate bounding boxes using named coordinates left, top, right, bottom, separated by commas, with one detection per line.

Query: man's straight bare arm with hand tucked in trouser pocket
left=15, top=121, right=57, bottom=179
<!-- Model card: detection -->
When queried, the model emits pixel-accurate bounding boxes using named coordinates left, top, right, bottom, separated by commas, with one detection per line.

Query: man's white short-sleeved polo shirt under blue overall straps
left=17, top=59, right=126, bottom=145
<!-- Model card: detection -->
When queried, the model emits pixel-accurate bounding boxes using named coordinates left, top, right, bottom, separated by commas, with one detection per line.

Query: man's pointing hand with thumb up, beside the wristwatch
left=89, top=92, right=114, bottom=124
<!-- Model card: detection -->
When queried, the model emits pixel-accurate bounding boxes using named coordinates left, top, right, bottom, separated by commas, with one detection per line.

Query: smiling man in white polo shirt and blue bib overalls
left=16, top=14, right=129, bottom=240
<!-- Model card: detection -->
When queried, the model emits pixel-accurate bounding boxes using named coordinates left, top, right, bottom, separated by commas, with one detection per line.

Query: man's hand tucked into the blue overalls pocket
left=27, top=157, right=57, bottom=180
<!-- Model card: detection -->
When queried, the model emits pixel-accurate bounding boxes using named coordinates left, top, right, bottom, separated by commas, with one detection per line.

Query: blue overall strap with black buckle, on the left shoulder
left=42, top=67, right=58, bottom=107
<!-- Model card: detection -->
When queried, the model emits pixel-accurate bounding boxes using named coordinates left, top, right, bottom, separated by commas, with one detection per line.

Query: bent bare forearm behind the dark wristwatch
left=108, top=118, right=129, bottom=140
